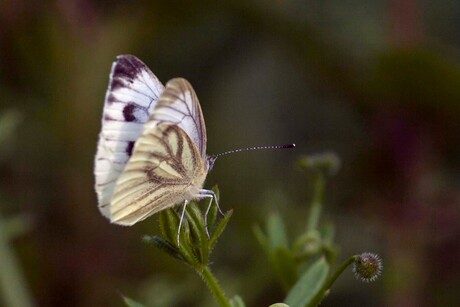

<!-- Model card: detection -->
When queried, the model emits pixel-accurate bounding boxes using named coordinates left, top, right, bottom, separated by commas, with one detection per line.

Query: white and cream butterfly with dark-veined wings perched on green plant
left=94, top=55, right=217, bottom=226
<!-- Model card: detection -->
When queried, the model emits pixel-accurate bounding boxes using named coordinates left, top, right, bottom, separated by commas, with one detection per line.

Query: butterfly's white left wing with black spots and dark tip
left=94, top=55, right=164, bottom=217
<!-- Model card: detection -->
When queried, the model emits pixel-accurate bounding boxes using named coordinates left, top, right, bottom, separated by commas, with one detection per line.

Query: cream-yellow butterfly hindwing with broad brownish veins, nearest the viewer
left=110, top=123, right=207, bottom=226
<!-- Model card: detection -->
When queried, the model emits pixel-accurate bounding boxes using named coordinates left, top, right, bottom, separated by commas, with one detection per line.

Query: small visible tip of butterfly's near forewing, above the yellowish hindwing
left=151, top=78, right=207, bottom=160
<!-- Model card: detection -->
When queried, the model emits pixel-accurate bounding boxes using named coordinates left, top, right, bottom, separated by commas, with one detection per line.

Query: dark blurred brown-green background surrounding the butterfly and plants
left=0, top=0, right=460, bottom=306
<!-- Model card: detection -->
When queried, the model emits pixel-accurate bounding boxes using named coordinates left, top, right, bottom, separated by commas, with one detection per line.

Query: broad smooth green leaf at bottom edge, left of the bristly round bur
left=285, top=258, right=329, bottom=307
